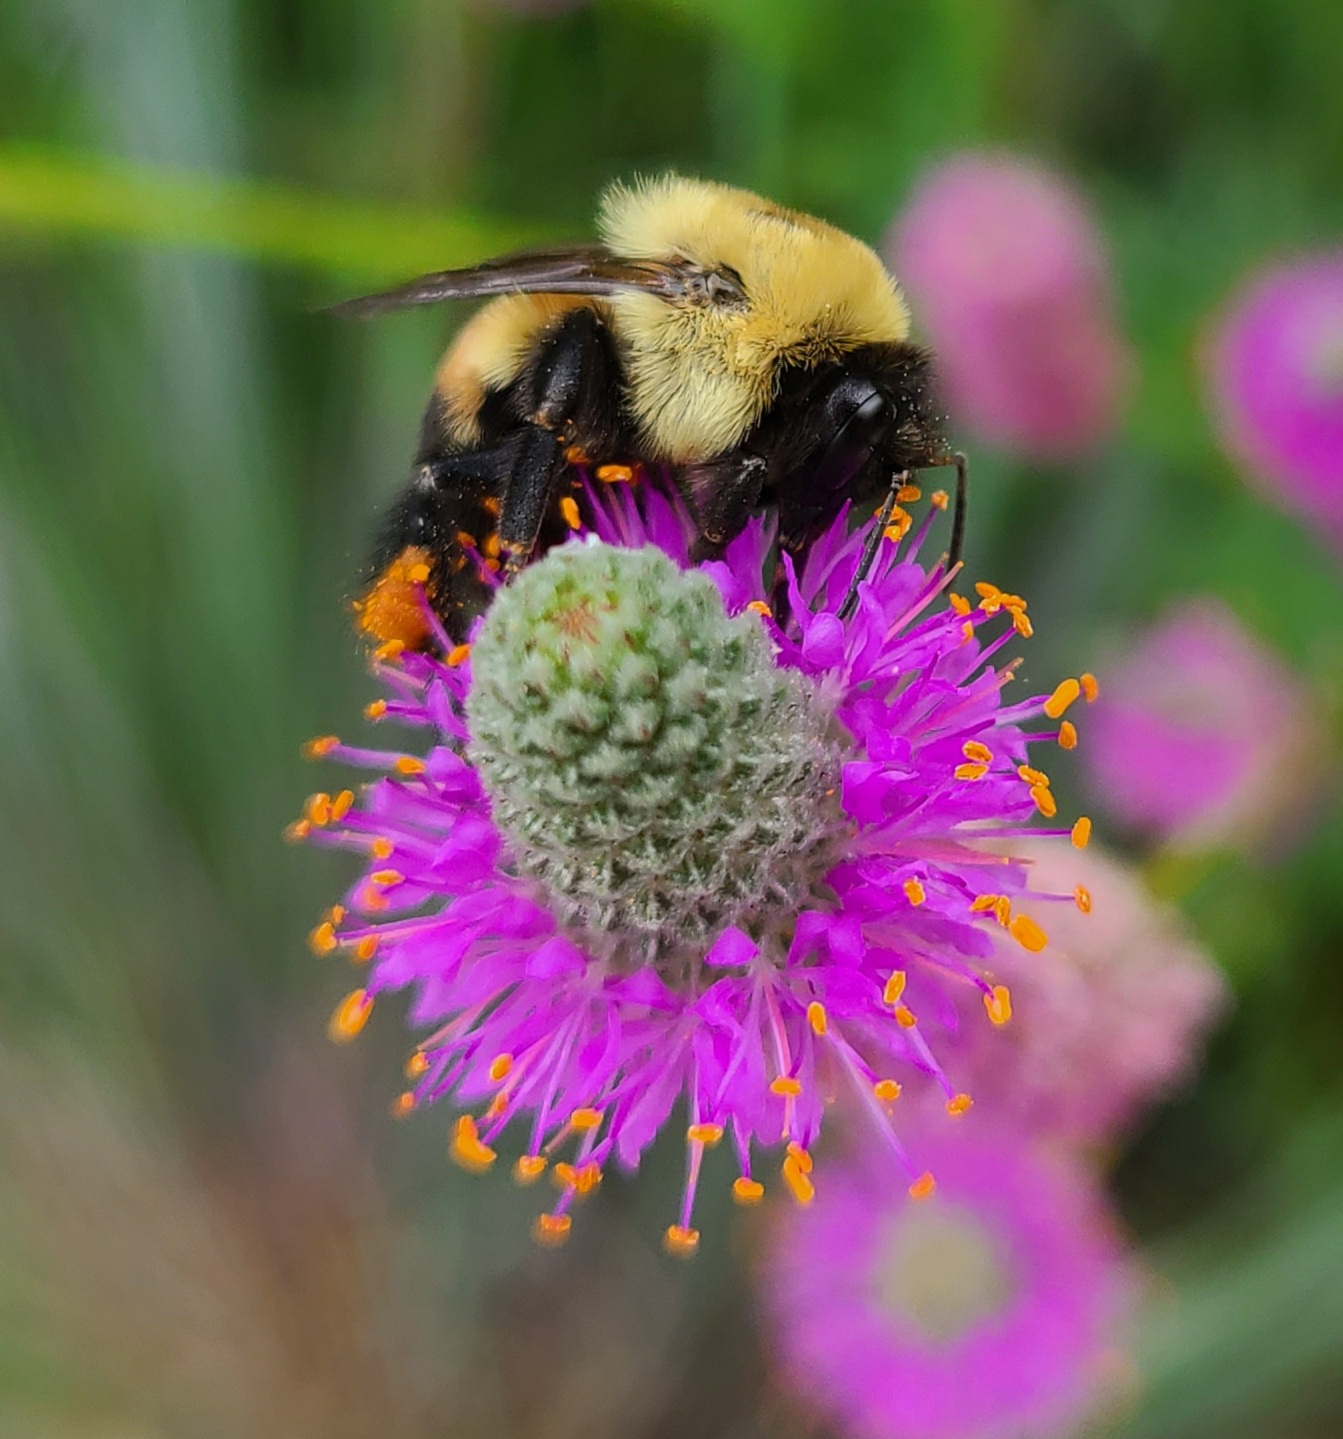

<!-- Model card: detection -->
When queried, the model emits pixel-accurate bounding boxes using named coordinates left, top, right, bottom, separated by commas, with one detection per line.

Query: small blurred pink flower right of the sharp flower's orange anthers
left=1081, top=599, right=1323, bottom=850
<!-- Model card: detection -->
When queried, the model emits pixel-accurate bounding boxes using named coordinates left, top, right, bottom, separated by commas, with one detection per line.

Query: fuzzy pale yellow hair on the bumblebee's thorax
left=599, top=176, right=910, bottom=460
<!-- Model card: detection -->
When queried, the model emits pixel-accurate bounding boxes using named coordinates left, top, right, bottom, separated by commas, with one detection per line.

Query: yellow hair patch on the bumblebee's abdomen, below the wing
left=433, top=295, right=600, bottom=448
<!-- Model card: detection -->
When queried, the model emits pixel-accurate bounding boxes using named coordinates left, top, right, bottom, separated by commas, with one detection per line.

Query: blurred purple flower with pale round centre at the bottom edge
left=761, top=1120, right=1131, bottom=1439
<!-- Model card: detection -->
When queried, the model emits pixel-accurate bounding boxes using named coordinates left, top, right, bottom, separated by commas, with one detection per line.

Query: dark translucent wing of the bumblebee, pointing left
left=333, top=245, right=685, bottom=315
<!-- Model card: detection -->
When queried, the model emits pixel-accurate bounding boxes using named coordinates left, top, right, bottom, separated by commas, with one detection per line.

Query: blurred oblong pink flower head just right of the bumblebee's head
left=885, top=154, right=1130, bottom=459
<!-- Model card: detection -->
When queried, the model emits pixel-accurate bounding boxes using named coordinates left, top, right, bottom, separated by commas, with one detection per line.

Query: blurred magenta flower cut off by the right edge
left=1208, top=250, right=1343, bottom=545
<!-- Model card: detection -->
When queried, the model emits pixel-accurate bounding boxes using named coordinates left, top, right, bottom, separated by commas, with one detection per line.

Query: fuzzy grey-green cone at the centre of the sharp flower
left=466, top=541, right=844, bottom=979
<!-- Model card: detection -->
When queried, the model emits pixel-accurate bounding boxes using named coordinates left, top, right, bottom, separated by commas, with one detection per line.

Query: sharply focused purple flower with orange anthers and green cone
left=297, top=485, right=1085, bottom=1253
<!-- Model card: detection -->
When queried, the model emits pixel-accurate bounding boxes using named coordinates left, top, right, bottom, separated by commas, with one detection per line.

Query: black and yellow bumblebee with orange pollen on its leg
left=337, top=176, right=966, bottom=648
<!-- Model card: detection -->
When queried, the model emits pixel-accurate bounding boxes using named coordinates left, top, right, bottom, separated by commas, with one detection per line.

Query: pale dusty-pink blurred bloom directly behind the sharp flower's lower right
left=939, top=840, right=1228, bottom=1143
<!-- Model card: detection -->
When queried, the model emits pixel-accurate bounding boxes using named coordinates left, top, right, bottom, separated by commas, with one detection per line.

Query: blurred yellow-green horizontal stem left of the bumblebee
left=0, top=145, right=546, bottom=281
